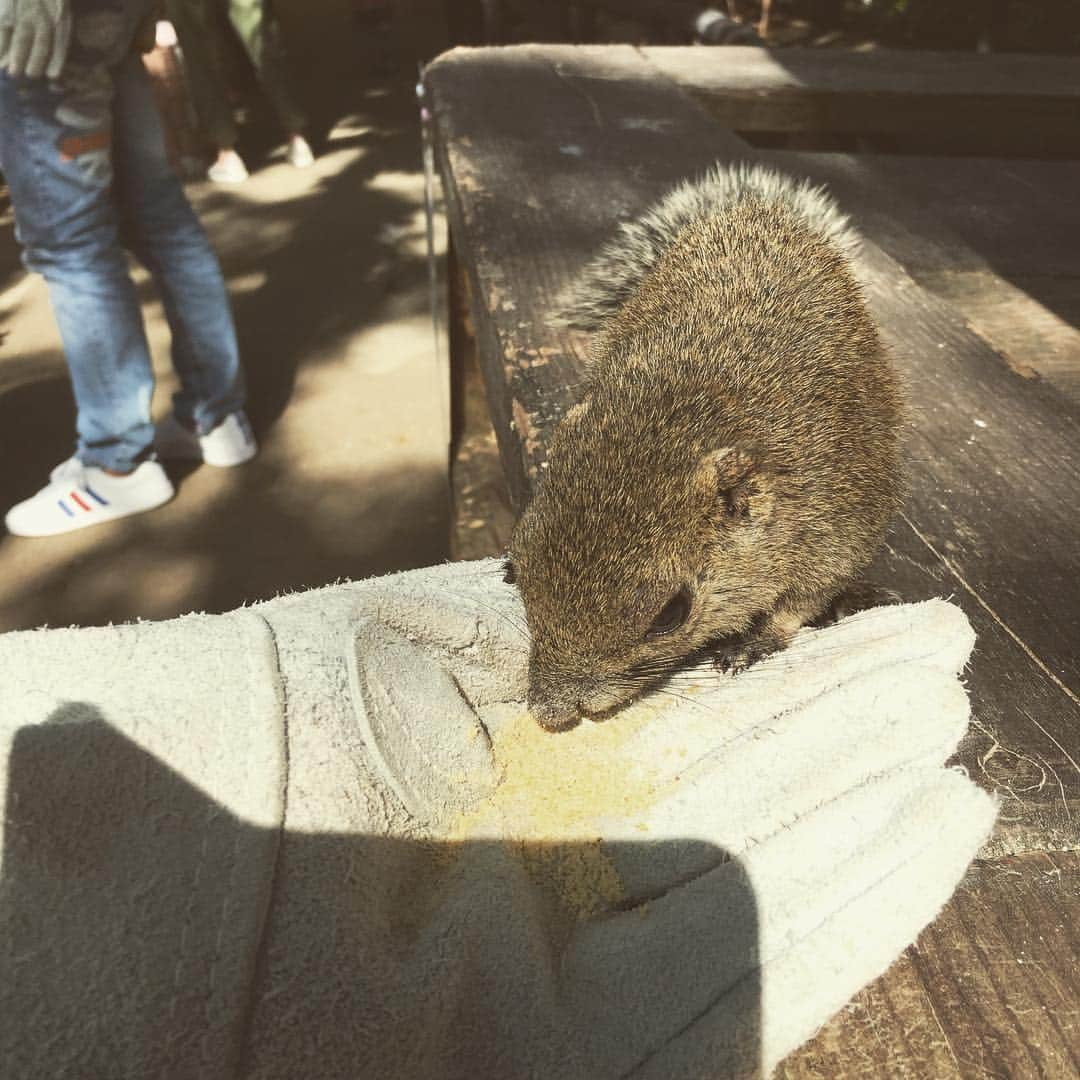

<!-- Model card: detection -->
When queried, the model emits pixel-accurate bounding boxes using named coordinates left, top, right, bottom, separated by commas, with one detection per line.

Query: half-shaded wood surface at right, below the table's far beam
left=770, top=153, right=1080, bottom=407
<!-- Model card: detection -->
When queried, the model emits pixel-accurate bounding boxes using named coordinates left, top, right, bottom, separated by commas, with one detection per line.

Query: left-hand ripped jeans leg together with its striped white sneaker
left=0, top=8, right=179, bottom=537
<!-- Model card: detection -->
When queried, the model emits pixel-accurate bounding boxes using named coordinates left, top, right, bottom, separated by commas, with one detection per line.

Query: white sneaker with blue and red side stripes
left=4, top=458, right=174, bottom=537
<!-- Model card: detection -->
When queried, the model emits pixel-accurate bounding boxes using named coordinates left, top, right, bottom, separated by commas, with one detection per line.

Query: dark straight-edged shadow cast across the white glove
left=0, top=702, right=760, bottom=1080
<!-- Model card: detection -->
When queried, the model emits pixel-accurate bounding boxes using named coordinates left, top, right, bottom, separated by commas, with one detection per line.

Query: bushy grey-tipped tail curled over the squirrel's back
left=562, top=162, right=859, bottom=329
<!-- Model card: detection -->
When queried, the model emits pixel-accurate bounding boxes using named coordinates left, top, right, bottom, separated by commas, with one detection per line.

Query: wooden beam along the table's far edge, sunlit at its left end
left=642, top=45, right=1080, bottom=152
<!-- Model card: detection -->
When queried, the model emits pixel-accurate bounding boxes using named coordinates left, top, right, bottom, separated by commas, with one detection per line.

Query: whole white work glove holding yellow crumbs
left=0, top=559, right=995, bottom=1080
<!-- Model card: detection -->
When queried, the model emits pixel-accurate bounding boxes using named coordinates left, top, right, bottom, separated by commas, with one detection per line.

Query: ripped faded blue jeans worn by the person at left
left=0, top=8, right=244, bottom=472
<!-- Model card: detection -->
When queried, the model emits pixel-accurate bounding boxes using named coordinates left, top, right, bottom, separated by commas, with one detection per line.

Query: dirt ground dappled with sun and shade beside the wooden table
left=0, top=23, right=460, bottom=630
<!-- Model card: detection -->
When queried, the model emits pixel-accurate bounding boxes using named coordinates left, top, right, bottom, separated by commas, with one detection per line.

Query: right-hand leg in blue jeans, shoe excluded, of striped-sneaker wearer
left=113, top=57, right=244, bottom=434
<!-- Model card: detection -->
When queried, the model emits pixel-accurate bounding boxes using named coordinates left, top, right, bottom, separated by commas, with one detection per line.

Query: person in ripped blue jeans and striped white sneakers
left=0, top=0, right=256, bottom=537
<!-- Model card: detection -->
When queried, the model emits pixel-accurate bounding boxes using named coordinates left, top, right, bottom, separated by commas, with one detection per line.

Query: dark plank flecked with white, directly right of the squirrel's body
left=751, top=153, right=1080, bottom=694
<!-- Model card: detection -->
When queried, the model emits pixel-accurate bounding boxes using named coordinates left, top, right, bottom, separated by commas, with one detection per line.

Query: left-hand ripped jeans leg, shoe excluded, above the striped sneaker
left=0, top=67, right=153, bottom=472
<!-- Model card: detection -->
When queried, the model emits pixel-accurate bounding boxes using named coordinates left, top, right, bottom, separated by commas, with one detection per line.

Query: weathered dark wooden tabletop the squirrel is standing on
left=427, top=46, right=1080, bottom=1077
